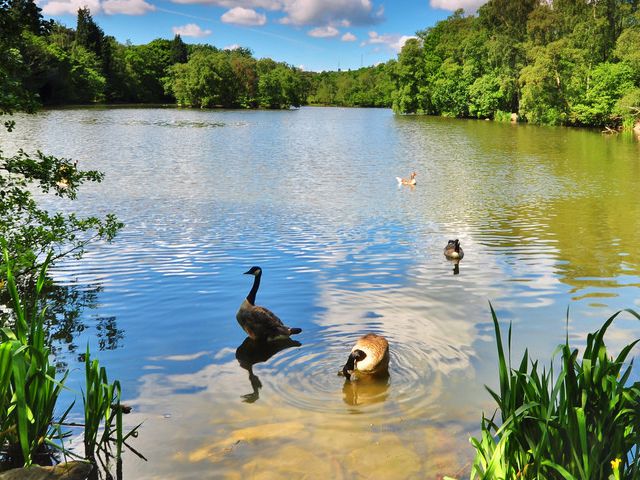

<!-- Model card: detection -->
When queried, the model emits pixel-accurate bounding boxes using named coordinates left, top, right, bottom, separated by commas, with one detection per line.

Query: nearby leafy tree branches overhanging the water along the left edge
left=0, top=0, right=122, bottom=275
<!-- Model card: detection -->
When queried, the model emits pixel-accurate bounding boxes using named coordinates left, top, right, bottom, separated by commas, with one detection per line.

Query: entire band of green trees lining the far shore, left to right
left=0, top=0, right=640, bottom=127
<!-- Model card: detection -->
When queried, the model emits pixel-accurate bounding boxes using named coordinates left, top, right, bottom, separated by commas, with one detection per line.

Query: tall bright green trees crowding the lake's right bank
left=394, top=0, right=640, bottom=126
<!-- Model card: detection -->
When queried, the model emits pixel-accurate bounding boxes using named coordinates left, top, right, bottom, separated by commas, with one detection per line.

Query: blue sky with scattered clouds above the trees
left=38, top=0, right=483, bottom=71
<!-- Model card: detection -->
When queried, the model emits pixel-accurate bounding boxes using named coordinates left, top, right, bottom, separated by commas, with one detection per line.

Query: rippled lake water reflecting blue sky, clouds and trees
left=1, top=108, right=640, bottom=479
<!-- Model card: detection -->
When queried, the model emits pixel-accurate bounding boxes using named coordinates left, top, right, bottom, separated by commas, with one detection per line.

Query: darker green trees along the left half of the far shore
left=0, top=0, right=309, bottom=109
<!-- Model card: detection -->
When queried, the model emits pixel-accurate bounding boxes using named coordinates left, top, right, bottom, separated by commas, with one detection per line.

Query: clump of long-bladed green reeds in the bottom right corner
left=471, top=307, right=640, bottom=480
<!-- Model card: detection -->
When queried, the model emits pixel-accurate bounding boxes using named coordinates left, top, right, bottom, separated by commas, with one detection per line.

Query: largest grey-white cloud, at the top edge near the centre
left=281, top=0, right=382, bottom=26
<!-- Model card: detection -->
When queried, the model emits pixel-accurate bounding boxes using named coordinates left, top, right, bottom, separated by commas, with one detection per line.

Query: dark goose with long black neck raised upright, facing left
left=236, top=267, right=302, bottom=340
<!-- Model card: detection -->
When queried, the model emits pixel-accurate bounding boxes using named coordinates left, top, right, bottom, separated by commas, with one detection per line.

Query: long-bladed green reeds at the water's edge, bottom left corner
left=0, top=248, right=138, bottom=466
